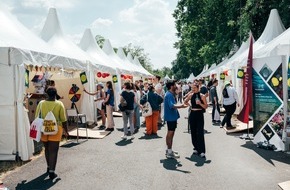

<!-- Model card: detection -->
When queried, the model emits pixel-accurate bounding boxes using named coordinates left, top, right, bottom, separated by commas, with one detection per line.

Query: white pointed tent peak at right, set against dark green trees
left=257, top=9, right=285, bottom=44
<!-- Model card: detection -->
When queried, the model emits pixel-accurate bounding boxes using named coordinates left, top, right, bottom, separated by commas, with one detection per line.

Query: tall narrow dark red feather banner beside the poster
left=237, top=34, right=253, bottom=123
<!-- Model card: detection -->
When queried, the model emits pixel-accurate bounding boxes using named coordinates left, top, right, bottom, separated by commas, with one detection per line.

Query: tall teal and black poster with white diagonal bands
left=253, top=56, right=287, bottom=150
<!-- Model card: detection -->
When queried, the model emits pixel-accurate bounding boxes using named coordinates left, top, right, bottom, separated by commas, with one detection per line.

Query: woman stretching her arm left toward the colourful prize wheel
left=84, top=83, right=106, bottom=130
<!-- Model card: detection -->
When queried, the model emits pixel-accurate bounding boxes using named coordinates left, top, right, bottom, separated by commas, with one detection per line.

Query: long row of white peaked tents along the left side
left=0, top=7, right=152, bottom=160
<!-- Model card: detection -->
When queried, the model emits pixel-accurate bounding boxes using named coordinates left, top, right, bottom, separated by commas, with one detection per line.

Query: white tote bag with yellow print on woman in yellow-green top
left=41, top=104, right=58, bottom=135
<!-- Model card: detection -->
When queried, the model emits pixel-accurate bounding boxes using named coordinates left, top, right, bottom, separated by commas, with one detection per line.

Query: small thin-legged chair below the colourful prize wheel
left=66, top=109, right=89, bottom=143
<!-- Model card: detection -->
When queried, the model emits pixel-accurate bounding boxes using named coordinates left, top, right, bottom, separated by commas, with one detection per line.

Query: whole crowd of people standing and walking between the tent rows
left=35, top=76, right=239, bottom=179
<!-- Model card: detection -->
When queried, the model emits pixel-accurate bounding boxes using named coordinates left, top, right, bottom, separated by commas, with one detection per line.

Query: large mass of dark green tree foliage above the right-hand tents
left=172, top=0, right=290, bottom=78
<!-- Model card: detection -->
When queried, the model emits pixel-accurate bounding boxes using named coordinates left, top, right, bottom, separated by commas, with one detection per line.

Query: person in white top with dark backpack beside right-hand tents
left=221, top=81, right=240, bottom=129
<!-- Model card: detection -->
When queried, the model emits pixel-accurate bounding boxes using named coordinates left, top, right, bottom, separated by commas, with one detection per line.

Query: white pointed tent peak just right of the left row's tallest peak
left=79, top=28, right=101, bottom=51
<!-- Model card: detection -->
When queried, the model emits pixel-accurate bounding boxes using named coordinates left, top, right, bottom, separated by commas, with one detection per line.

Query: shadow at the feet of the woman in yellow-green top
left=15, top=173, right=60, bottom=190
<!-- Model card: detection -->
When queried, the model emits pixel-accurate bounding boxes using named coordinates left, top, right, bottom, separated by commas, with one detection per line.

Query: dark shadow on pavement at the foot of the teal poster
left=242, top=141, right=290, bottom=166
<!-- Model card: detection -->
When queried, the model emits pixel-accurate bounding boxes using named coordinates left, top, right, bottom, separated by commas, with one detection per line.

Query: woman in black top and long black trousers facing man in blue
left=185, top=84, right=208, bottom=158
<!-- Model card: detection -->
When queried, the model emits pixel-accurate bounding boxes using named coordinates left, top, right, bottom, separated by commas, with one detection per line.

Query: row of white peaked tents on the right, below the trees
left=196, top=9, right=290, bottom=113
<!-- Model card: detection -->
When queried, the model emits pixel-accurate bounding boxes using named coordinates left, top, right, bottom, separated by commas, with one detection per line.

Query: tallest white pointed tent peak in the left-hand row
left=40, top=8, right=63, bottom=41
